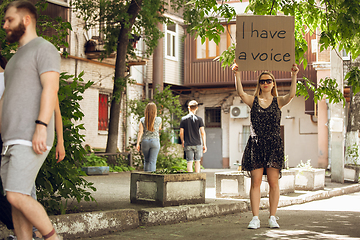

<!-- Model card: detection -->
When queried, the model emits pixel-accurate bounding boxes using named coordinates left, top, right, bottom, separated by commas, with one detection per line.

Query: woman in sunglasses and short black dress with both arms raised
left=233, top=64, right=299, bottom=229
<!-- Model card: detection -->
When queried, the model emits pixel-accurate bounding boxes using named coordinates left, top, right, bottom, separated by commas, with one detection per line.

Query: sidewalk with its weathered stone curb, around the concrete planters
left=0, top=169, right=360, bottom=239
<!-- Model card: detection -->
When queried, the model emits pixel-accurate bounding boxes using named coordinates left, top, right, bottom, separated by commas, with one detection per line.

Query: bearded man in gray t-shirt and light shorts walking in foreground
left=0, top=1, right=60, bottom=240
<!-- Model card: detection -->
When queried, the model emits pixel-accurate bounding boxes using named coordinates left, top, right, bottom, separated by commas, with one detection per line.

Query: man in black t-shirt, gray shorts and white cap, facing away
left=180, top=100, right=207, bottom=173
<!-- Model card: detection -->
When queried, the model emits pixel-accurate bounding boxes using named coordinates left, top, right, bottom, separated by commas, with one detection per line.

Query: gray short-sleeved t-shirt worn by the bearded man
left=1, top=37, right=60, bottom=146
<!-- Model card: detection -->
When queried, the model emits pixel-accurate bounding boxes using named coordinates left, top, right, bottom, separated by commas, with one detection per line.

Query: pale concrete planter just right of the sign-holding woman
left=290, top=168, right=325, bottom=191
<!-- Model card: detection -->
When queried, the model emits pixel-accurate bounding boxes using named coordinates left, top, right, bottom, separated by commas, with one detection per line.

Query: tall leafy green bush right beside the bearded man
left=36, top=72, right=96, bottom=214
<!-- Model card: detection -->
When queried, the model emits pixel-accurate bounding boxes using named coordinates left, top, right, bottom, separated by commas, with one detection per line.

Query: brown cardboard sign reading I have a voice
left=235, top=15, right=295, bottom=71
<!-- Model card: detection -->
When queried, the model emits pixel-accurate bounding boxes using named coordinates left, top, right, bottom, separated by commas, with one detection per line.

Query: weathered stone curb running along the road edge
left=0, top=184, right=360, bottom=239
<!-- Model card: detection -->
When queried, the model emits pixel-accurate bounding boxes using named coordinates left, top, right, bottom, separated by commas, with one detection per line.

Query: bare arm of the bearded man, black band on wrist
left=32, top=72, right=59, bottom=154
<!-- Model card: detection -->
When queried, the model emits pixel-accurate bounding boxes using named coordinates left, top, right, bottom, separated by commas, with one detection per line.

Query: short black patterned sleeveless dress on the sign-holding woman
left=242, top=96, right=284, bottom=177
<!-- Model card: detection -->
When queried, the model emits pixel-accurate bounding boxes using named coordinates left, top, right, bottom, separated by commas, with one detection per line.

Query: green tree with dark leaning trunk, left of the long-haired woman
left=72, top=0, right=171, bottom=153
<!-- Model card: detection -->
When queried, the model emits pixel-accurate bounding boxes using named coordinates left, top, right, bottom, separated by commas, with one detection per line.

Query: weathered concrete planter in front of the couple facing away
left=130, top=173, right=206, bottom=207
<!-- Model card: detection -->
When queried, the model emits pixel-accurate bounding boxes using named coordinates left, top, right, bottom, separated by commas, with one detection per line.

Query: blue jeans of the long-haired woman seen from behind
left=141, top=138, right=160, bottom=172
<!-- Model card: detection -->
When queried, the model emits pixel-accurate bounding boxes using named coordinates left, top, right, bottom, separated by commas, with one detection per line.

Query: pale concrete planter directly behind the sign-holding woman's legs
left=215, top=172, right=269, bottom=198
